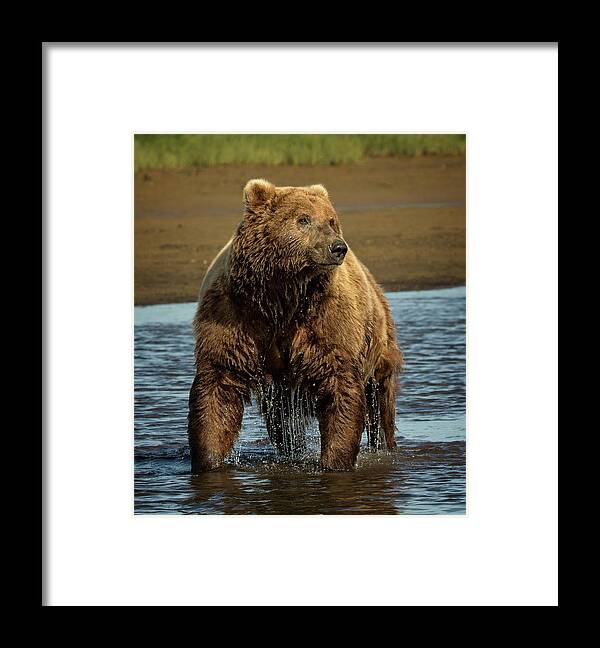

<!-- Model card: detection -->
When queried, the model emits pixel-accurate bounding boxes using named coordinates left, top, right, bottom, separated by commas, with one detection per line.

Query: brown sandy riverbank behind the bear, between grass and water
left=134, top=156, right=466, bottom=304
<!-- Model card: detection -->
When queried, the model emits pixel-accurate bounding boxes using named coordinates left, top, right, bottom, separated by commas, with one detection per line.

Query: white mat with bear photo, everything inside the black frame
left=41, top=42, right=558, bottom=606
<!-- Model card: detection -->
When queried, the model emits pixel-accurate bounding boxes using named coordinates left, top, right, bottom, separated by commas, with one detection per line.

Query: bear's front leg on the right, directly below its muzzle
left=319, top=375, right=366, bottom=470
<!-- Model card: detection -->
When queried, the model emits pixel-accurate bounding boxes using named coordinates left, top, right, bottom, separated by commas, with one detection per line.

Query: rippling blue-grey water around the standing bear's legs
left=135, top=288, right=466, bottom=514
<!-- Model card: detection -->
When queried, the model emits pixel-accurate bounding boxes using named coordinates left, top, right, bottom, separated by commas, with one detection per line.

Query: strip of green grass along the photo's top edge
left=135, top=135, right=465, bottom=171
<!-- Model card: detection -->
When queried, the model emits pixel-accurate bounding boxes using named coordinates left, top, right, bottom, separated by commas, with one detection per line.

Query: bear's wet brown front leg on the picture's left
left=188, top=366, right=246, bottom=473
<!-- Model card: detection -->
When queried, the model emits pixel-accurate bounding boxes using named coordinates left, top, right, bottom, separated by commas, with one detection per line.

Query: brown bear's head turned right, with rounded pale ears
left=238, top=179, right=348, bottom=276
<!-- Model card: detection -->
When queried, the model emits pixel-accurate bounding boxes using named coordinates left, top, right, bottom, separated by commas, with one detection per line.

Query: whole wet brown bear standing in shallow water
left=188, top=180, right=402, bottom=472
